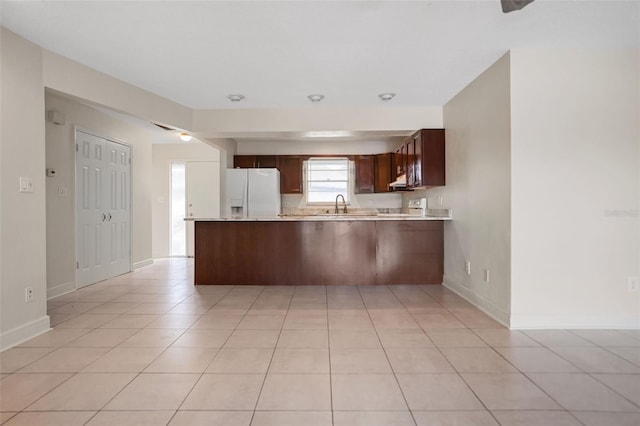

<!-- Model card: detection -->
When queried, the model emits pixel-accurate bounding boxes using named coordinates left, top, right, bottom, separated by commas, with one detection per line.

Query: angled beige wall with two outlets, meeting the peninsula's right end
left=430, top=54, right=511, bottom=324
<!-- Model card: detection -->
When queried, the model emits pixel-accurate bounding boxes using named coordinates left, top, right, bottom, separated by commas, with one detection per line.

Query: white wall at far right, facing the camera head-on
left=511, top=49, right=640, bottom=328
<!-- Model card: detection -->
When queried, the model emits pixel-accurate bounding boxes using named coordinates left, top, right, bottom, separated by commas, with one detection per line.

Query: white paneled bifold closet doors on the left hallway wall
left=76, top=131, right=131, bottom=287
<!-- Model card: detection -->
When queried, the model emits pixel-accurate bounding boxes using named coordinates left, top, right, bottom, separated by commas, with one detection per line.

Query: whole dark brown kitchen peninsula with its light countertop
left=193, top=214, right=450, bottom=285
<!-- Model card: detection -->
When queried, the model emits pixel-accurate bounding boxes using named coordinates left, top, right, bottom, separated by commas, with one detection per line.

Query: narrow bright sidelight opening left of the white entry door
left=170, top=161, right=187, bottom=256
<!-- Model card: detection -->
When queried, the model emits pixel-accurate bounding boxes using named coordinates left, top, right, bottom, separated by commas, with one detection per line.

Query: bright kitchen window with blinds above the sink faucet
left=306, top=157, right=350, bottom=204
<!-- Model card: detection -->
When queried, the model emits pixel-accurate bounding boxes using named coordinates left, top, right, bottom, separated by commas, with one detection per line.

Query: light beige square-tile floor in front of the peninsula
left=0, top=259, right=640, bottom=426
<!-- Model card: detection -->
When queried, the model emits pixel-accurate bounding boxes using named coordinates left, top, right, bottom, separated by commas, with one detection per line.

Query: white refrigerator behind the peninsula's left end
left=226, top=169, right=280, bottom=218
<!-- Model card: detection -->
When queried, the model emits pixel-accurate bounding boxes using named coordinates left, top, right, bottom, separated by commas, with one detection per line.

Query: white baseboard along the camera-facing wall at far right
left=511, top=315, right=640, bottom=330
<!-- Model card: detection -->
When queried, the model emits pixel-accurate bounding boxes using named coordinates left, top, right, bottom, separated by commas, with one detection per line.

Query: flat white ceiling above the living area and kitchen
left=0, top=0, right=640, bottom=113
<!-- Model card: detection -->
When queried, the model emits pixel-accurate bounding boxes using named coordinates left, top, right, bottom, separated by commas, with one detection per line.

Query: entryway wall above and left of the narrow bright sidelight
left=152, top=142, right=222, bottom=257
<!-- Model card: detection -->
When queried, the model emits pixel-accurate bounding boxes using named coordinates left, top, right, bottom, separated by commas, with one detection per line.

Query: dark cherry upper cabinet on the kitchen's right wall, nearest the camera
left=407, top=129, right=445, bottom=187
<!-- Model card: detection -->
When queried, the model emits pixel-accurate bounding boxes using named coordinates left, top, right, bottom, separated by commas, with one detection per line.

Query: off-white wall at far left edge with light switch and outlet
left=0, top=28, right=49, bottom=350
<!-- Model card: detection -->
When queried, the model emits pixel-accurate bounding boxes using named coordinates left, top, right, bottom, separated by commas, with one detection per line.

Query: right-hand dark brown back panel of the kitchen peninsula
left=376, top=221, right=444, bottom=285
